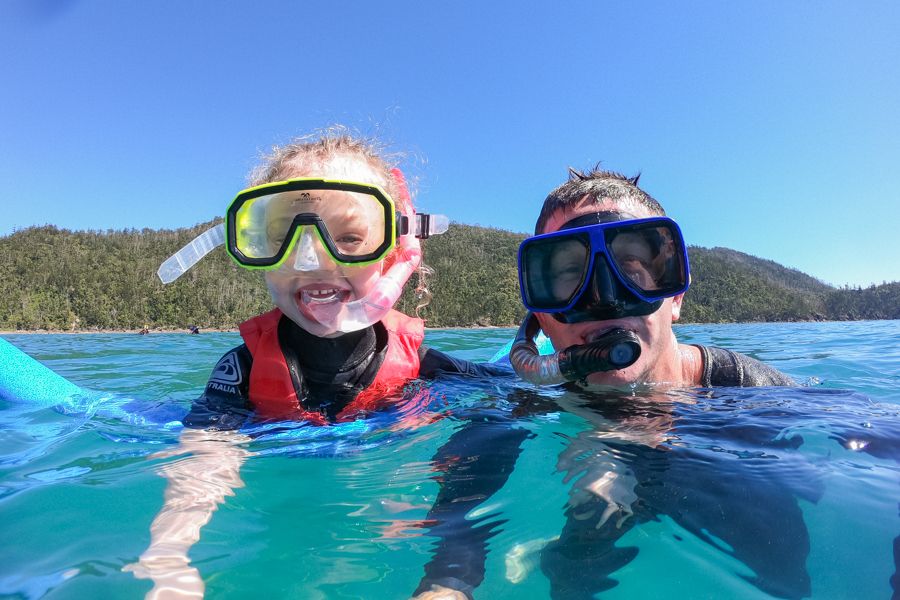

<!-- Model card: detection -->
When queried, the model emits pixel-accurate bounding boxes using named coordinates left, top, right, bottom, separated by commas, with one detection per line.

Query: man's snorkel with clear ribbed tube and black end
left=509, top=313, right=641, bottom=385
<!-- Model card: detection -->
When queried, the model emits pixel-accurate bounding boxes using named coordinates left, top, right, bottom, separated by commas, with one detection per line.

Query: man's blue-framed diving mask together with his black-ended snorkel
left=510, top=212, right=690, bottom=385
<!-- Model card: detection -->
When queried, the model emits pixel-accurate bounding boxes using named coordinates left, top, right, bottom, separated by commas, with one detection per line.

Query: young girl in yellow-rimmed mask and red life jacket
left=126, top=132, right=507, bottom=597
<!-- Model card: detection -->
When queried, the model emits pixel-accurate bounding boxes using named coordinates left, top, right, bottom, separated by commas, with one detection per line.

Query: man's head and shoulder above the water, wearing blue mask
left=511, top=169, right=796, bottom=388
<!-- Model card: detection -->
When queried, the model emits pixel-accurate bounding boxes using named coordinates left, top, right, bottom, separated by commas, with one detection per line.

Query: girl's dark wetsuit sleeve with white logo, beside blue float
left=183, top=344, right=253, bottom=430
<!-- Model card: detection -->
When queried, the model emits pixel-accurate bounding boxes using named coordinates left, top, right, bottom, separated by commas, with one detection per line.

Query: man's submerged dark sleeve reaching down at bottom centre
left=414, top=409, right=532, bottom=598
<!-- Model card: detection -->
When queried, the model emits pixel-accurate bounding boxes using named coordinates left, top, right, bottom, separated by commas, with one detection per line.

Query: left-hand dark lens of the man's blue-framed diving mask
left=522, top=235, right=590, bottom=310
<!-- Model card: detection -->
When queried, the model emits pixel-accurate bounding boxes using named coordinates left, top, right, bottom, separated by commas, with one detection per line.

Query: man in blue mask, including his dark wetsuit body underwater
left=416, top=169, right=804, bottom=599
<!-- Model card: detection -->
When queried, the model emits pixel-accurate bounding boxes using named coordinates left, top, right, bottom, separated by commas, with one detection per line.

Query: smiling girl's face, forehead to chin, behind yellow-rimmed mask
left=265, top=159, right=396, bottom=337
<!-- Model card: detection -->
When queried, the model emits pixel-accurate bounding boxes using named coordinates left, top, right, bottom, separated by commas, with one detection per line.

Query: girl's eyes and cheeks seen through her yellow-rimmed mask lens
left=266, top=190, right=384, bottom=256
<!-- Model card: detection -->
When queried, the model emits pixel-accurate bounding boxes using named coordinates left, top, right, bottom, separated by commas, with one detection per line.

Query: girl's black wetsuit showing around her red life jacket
left=184, top=316, right=513, bottom=429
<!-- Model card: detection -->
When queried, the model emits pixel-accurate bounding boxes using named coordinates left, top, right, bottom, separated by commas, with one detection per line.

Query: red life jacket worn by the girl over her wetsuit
left=239, top=308, right=425, bottom=425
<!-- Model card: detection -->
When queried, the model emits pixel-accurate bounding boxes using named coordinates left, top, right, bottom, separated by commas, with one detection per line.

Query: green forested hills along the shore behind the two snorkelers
left=0, top=222, right=900, bottom=330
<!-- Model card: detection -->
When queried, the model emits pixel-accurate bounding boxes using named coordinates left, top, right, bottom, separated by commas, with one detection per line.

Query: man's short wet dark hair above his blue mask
left=534, top=168, right=666, bottom=235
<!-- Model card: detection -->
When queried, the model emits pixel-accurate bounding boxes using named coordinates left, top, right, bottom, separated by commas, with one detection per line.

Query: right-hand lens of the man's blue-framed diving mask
left=604, top=222, right=687, bottom=298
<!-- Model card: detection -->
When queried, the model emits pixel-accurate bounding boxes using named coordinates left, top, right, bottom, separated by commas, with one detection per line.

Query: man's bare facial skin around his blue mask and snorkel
left=537, top=199, right=682, bottom=386
